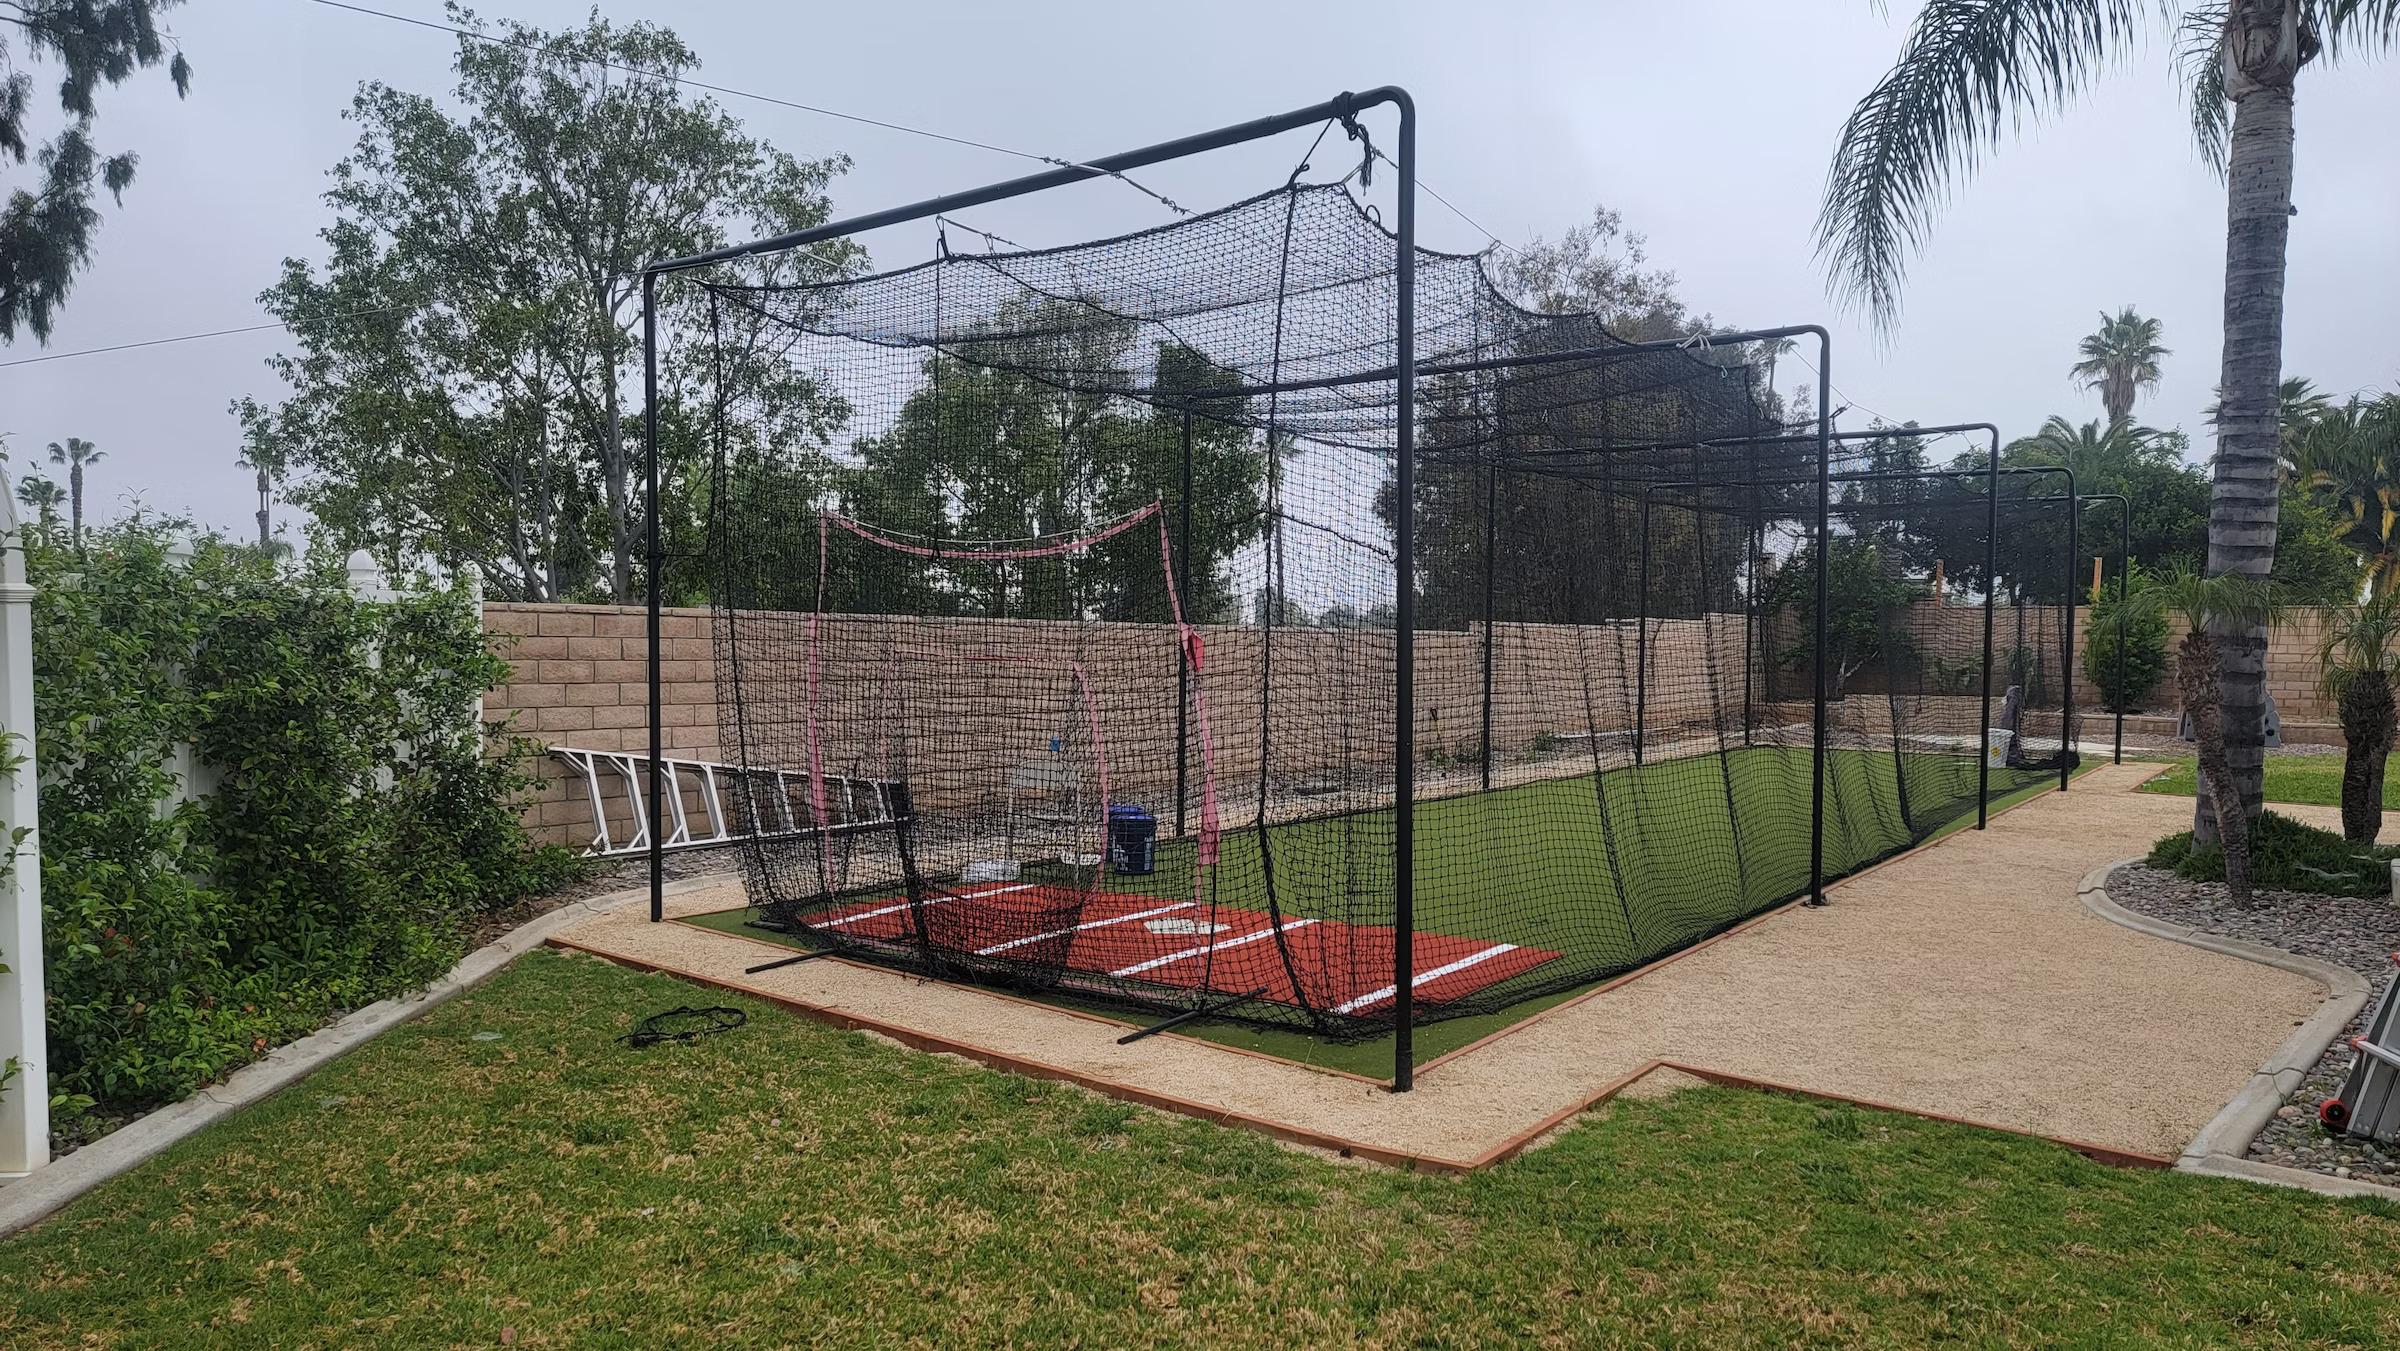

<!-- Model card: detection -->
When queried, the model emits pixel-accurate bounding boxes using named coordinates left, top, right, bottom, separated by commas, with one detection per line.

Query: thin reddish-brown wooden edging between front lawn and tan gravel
left=550, top=933, right=2172, bottom=1176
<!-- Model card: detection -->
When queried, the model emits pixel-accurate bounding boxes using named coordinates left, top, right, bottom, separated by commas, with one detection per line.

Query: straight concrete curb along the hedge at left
left=0, top=876, right=720, bottom=1238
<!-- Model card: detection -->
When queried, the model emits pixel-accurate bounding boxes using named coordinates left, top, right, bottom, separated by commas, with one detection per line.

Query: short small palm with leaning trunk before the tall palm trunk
left=2126, top=571, right=2282, bottom=905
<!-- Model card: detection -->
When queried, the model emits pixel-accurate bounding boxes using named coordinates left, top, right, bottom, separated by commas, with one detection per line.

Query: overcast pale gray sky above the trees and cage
left=0, top=0, right=2400, bottom=539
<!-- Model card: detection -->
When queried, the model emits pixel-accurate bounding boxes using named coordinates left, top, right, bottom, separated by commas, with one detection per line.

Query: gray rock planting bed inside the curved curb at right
left=2107, top=864, right=2400, bottom=1183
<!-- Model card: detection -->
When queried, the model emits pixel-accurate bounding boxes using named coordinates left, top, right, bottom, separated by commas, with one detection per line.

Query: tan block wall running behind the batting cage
left=485, top=602, right=2333, bottom=845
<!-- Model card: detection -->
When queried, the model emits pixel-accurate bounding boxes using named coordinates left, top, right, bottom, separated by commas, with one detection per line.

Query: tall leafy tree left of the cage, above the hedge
left=242, top=7, right=857, bottom=600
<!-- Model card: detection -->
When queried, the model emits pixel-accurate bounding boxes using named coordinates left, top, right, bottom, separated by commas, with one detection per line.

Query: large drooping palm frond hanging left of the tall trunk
left=1817, top=0, right=2160, bottom=331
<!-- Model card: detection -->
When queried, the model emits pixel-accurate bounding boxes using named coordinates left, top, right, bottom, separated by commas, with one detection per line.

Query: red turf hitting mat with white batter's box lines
left=809, top=883, right=1558, bottom=1017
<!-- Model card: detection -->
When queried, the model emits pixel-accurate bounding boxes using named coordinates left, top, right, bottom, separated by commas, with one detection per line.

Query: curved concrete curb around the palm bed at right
left=2076, top=859, right=2400, bottom=1200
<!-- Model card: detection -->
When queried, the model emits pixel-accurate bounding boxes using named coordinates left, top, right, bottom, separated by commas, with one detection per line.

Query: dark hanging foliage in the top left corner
left=0, top=0, right=192, bottom=343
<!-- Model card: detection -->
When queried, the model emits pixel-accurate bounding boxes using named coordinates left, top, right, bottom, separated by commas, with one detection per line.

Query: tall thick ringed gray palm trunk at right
left=2186, top=13, right=2302, bottom=844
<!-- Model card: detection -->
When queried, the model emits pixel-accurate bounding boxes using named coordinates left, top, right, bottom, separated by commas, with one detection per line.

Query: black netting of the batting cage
left=662, top=182, right=2074, bottom=1039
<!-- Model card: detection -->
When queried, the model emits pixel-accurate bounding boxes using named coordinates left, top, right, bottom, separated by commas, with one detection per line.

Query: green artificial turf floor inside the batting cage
left=696, top=746, right=2057, bottom=1077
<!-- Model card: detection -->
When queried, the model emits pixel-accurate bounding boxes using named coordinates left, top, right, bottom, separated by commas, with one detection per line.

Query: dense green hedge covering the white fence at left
left=26, top=521, right=576, bottom=1123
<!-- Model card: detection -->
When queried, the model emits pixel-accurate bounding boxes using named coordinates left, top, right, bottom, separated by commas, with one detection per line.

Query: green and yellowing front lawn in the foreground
left=0, top=953, right=2400, bottom=1351
